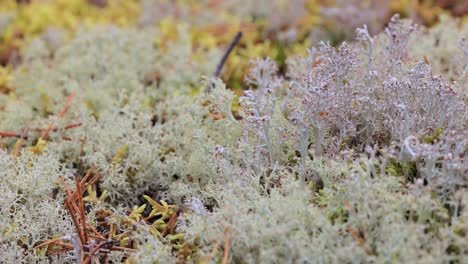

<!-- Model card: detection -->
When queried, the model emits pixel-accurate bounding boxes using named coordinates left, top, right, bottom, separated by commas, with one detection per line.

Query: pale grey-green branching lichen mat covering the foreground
left=0, top=16, right=468, bottom=263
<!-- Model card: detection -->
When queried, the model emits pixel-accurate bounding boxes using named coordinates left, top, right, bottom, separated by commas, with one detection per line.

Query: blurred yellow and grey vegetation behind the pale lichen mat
left=0, top=0, right=468, bottom=91
